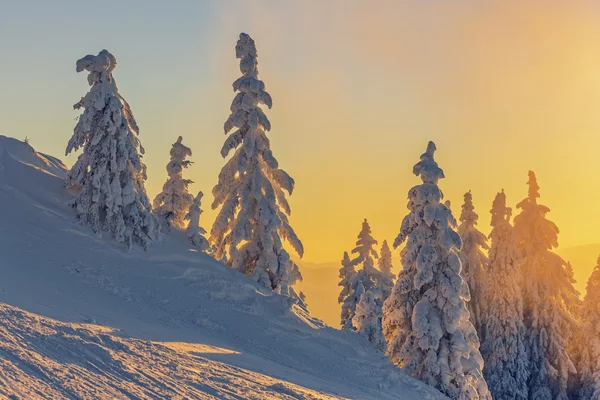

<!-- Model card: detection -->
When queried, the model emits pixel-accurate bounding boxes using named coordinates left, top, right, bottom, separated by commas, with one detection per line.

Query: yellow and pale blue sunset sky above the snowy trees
left=0, top=0, right=600, bottom=278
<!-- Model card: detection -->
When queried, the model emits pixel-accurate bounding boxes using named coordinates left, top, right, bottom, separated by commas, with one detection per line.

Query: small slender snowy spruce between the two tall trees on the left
left=153, top=136, right=194, bottom=230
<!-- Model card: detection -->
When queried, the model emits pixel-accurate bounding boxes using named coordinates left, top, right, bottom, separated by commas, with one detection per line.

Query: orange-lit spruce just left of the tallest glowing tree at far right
left=481, top=191, right=529, bottom=400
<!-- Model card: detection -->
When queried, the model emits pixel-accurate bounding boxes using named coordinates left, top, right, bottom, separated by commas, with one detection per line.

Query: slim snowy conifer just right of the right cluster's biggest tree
left=458, top=191, right=489, bottom=340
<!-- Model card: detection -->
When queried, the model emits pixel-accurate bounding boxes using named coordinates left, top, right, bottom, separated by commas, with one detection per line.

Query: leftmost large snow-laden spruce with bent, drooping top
left=66, top=50, right=159, bottom=249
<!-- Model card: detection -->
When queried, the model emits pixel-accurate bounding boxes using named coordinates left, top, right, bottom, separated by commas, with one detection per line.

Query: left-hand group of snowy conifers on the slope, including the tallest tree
left=66, top=33, right=304, bottom=301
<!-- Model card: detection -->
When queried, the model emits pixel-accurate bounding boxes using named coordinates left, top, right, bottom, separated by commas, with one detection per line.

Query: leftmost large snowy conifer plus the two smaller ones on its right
left=66, top=50, right=208, bottom=251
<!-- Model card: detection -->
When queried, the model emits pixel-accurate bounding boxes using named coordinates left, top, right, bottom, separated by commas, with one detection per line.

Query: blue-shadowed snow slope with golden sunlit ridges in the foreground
left=0, top=136, right=443, bottom=399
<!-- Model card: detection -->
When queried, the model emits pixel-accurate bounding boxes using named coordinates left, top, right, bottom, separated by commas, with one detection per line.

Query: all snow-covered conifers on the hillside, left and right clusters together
left=57, top=33, right=600, bottom=400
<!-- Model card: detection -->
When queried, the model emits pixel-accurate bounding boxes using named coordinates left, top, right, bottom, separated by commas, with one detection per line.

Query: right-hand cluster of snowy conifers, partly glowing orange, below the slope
left=338, top=142, right=600, bottom=400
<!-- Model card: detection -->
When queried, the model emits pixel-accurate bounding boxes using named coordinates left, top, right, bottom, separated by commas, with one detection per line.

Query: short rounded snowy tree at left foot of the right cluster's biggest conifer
left=352, top=287, right=385, bottom=352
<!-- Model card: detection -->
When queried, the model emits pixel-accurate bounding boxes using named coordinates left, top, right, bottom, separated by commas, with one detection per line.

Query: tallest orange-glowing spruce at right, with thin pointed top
left=514, top=171, right=577, bottom=400
